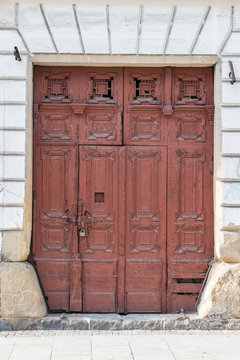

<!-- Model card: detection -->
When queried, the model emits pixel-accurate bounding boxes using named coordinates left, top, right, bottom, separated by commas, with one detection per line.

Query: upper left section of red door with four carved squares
left=34, top=66, right=123, bottom=145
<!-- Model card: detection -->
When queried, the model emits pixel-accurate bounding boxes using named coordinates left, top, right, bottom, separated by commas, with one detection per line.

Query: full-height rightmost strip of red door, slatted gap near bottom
left=167, top=69, right=214, bottom=312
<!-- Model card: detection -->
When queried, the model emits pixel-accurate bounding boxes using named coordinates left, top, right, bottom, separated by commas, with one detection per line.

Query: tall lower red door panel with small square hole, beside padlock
left=79, top=146, right=124, bottom=312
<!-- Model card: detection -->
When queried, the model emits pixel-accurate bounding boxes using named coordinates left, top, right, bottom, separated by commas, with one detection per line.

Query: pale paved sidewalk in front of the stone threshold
left=0, top=330, right=240, bottom=360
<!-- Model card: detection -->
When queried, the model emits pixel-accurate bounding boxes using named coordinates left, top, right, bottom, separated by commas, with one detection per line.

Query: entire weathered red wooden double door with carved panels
left=32, top=67, right=213, bottom=313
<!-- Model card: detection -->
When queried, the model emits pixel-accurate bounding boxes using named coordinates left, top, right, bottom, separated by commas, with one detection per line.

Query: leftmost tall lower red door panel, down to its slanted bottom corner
left=33, top=143, right=77, bottom=310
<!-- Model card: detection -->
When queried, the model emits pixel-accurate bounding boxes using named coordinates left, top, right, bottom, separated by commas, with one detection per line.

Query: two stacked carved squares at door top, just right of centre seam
left=124, top=68, right=167, bottom=145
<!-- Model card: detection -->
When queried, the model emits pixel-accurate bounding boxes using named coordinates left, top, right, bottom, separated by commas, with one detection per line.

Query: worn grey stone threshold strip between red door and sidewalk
left=0, top=313, right=240, bottom=331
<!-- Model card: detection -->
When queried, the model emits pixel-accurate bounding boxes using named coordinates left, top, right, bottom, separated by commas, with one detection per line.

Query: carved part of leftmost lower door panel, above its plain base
left=35, top=145, right=76, bottom=256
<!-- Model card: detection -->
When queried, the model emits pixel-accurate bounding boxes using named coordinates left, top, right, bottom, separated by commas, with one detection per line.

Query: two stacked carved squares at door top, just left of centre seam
left=79, top=68, right=123, bottom=145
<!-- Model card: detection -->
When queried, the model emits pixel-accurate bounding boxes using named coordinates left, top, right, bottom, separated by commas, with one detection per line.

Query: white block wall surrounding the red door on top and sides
left=0, top=0, right=240, bottom=261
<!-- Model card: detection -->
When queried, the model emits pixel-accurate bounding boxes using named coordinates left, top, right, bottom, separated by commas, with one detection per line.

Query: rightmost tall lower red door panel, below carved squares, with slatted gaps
left=168, top=144, right=213, bottom=312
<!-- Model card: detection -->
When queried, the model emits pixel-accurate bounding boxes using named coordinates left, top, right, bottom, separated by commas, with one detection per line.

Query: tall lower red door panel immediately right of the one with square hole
left=125, top=147, right=167, bottom=312
